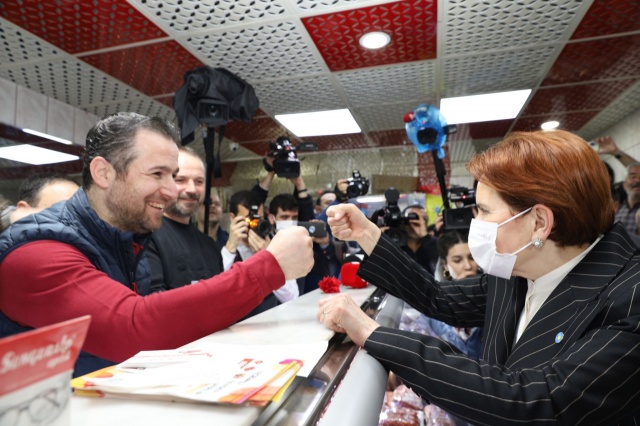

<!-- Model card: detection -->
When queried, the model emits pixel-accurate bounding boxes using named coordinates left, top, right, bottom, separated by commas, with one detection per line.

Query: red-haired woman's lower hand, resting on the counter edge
left=316, top=293, right=380, bottom=347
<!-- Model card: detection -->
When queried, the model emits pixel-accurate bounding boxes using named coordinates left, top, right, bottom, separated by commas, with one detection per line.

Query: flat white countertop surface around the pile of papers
left=70, top=286, right=375, bottom=426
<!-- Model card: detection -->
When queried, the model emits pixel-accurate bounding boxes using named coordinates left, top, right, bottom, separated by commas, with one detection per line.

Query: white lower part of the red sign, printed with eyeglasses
left=0, top=382, right=71, bottom=426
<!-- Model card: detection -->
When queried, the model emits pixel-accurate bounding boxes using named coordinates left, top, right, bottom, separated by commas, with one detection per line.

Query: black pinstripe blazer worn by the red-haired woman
left=359, top=224, right=640, bottom=426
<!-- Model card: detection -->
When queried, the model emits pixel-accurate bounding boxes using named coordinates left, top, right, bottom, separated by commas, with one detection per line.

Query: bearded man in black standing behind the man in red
left=145, top=147, right=223, bottom=293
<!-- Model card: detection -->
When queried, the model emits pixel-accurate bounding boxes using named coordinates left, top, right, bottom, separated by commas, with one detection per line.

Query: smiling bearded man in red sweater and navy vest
left=0, top=113, right=313, bottom=376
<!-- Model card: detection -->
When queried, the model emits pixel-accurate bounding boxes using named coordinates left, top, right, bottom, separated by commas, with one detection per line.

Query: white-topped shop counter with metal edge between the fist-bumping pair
left=71, top=286, right=403, bottom=426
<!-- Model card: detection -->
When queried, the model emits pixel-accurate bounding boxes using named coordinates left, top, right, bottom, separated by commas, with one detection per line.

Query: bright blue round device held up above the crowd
left=404, top=104, right=457, bottom=160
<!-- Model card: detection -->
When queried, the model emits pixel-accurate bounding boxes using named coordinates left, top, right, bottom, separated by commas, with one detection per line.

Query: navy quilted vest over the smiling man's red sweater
left=0, top=188, right=150, bottom=376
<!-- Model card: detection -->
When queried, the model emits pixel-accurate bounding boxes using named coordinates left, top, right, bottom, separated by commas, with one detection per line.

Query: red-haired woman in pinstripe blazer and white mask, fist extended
left=318, top=131, right=640, bottom=426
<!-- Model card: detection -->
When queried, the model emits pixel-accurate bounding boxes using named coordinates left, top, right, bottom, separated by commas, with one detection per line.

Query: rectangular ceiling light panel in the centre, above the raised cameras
left=276, top=109, right=361, bottom=137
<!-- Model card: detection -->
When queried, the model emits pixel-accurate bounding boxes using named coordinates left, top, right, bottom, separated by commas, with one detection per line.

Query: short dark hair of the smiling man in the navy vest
left=82, top=112, right=180, bottom=189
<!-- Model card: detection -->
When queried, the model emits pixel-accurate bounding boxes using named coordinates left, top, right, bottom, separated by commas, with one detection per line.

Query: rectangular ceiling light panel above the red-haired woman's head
left=440, top=89, right=531, bottom=124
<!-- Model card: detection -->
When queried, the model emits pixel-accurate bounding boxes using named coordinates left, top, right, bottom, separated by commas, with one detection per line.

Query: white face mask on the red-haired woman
left=469, top=207, right=533, bottom=279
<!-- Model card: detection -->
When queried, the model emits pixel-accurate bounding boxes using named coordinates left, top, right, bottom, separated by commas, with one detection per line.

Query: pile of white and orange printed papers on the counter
left=71, top=347, right=302, bottom=405
